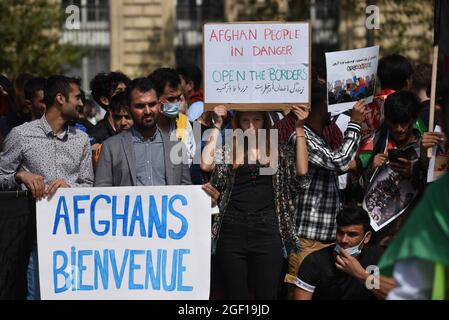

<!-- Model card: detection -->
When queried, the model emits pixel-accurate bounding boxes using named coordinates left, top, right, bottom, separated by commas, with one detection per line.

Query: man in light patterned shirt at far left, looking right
left=0, top=76, right=94, bottom=299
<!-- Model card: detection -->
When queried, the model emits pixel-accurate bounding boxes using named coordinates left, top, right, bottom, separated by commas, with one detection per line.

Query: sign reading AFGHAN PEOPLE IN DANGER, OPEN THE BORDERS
left=204, top=23, right=310, bottom=110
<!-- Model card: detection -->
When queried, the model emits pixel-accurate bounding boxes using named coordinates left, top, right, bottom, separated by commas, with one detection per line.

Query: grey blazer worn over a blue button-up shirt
left=94, top=131, right=192, bottom=187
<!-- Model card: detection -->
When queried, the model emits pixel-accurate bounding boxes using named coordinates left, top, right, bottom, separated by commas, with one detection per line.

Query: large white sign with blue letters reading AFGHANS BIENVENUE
left=36, top=186, right=211, bottom=300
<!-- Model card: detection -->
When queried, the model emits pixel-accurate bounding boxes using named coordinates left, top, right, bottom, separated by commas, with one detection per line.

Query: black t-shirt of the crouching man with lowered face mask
left=297, top=245, right=383, bottom=300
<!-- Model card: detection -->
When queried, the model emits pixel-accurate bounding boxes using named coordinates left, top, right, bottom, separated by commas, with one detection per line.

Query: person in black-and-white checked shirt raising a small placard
left=285, top=81, right=366, bottom=299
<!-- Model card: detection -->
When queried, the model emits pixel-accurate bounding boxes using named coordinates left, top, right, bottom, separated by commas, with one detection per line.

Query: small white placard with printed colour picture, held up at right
left=326, top=46, right=379, bottom=115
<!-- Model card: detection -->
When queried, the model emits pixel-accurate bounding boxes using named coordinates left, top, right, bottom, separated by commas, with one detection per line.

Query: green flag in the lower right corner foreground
left=379, top=174, right=449, bottom=299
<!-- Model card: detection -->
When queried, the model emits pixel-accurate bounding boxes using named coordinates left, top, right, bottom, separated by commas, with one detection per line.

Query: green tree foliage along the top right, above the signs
left=239, top=0, right=435, bottom=62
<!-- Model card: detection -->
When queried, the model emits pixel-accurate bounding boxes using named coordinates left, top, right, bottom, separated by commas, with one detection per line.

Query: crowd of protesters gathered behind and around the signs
left=0, top=54, right=449, bottom=300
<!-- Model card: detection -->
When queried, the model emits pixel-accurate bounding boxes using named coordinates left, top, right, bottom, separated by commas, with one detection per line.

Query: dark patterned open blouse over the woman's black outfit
left=210, top=144, right=310, bottom=257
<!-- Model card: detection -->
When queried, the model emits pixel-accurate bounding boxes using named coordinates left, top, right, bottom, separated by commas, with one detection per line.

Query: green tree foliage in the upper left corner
left=0, top=0, right=84, bottom=76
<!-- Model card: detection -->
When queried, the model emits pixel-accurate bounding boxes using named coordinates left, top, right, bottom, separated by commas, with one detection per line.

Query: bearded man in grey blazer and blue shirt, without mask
left=95, top=78, right=191, bottom=187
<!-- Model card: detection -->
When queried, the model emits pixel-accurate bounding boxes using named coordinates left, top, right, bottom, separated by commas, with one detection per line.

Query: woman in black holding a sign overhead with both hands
left=201, top=106, right=309, bottom=300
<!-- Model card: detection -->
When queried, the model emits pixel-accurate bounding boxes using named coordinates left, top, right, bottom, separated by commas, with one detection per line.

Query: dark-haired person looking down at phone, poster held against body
left=360, top=90, right=427, bottom=242
